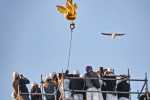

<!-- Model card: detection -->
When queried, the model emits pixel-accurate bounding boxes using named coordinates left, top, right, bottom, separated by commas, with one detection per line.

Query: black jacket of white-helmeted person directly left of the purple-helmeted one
left=69, top=76, right=84, bottom=94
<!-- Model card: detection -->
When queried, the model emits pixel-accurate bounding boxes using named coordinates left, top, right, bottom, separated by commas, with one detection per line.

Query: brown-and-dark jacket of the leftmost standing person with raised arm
left=13, top=78, right=30, bottom=94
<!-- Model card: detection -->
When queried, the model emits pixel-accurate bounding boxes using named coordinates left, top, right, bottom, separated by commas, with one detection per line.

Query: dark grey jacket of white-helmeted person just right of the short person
left=44, top=80, right=56, bottom=100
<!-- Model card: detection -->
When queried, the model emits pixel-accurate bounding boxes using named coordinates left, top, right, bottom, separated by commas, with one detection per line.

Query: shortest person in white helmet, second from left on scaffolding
left=31, top=82, right=42, bottom=100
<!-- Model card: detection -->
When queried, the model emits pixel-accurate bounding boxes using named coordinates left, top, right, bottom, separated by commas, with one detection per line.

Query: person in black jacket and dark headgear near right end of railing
left=117, top=75, right=130, bottom=100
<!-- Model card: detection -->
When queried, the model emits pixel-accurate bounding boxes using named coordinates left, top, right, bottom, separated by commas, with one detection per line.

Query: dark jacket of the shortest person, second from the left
left=31, top=86, right=42, bottom=100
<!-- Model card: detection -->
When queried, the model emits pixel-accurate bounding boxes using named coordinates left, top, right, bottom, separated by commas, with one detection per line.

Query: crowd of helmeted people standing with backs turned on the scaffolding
left=12, top=66, right=148, bottom=100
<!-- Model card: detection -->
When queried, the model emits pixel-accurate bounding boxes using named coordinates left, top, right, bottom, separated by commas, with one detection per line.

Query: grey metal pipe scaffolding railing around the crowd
left=18, top=69, right=149, bottom=100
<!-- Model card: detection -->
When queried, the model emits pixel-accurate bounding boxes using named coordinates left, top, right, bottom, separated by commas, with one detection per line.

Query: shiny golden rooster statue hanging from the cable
left=56, top=0, right=78, bottom=22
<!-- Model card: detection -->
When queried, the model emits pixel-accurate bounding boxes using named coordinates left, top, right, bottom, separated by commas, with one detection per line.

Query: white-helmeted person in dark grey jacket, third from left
left=44, top=76, right=56, bottom=100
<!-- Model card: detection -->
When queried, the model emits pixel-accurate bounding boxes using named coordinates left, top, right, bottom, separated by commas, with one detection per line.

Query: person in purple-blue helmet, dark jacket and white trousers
left=85, top=66, right=100, bottom=100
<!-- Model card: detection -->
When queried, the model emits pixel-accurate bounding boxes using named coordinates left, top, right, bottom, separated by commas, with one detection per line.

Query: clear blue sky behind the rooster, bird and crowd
left=0, top=0, right=150, bottom=100
